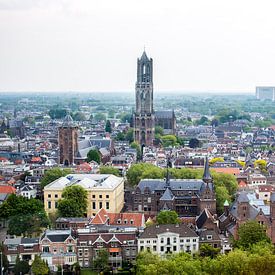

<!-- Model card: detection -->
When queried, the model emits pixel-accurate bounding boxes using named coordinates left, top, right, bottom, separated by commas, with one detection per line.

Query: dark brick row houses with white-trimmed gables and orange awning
left=77, top=229, right=137, bottom=267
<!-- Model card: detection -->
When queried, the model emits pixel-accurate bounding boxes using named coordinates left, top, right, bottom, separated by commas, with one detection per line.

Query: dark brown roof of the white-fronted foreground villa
left=139, top=223, right=198, bottom=239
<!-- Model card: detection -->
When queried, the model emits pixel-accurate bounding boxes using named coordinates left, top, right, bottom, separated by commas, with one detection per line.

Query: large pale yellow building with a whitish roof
left=44, top=174, right=124, bottom=217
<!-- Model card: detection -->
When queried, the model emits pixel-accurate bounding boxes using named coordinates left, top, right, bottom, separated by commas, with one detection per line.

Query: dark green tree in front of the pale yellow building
left=57, top=185, right=88, bottom=217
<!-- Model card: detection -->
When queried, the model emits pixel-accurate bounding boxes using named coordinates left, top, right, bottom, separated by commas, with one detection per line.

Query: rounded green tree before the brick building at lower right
left=235, top=221, right=270, bottom=249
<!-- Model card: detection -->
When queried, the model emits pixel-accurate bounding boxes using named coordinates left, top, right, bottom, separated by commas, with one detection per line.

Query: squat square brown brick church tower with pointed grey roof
left=58, top=115, right=78, bottom=166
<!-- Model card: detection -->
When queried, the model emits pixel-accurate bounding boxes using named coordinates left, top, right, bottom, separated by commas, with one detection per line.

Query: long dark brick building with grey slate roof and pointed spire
left=125, top=160, right=216, bottom=216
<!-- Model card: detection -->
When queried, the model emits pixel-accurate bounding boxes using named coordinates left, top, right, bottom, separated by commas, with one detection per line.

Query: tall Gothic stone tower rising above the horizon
left=134, top=51, right=155, bottom=146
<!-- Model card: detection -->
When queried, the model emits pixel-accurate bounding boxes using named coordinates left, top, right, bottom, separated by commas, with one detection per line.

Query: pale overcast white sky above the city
left=0, top=0, right=275, bottom=93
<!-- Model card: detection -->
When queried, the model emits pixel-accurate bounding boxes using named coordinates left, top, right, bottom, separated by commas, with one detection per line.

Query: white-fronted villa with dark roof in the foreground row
left=138, top=224, right=199, bottom=255
